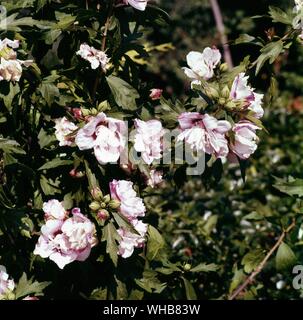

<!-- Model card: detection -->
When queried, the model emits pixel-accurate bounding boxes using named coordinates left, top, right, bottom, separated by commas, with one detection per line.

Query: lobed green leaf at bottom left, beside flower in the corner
left=15, top=273, right=51, bottom=299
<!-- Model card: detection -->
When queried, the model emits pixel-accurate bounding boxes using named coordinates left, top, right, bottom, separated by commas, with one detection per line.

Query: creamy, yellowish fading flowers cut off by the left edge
left=0, top=38, right=32, bottom=82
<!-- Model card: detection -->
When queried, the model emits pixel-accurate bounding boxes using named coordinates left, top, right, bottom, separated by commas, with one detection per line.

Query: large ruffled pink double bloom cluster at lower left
left=34, top=199, right=97, bottom=269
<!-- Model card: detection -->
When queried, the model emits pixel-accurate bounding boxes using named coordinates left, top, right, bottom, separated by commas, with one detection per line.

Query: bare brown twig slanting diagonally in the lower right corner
left=228, top=220, right=296, bottom=300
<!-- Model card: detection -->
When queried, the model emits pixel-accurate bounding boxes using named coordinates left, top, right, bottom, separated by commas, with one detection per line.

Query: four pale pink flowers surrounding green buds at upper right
left=178, top=48, right=264, bottom=160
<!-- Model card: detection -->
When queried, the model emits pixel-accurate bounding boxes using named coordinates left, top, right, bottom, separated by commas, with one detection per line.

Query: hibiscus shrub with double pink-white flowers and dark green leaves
left=0, top=0, right=303, bottom=300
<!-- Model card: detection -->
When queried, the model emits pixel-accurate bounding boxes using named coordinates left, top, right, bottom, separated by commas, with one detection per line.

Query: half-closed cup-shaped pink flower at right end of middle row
left=230, top=120, right=260, bottom=159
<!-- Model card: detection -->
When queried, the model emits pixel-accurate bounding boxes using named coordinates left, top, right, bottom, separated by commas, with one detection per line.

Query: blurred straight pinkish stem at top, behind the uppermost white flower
left=210, top=0, right=233, bottom=69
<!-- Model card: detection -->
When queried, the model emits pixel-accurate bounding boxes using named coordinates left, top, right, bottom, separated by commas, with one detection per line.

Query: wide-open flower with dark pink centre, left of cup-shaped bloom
left=177, top=112, right=231, bottom=158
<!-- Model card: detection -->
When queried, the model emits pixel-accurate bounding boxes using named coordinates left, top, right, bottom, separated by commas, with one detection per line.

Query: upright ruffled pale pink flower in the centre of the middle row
left=134, top=119, right=164, bottom=164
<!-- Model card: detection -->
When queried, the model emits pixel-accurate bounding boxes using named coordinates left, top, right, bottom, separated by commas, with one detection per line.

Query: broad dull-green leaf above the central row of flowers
left=106, top=76, right=140, bottom=110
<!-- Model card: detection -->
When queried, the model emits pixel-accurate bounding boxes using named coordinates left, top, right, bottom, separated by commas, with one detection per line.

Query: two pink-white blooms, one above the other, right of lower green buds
left=110, top=180, right=147, bottom=258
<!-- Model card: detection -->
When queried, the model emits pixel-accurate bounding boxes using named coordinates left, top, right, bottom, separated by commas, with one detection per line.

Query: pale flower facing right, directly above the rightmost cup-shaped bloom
left=230, top=72, right=264, bottom=119
